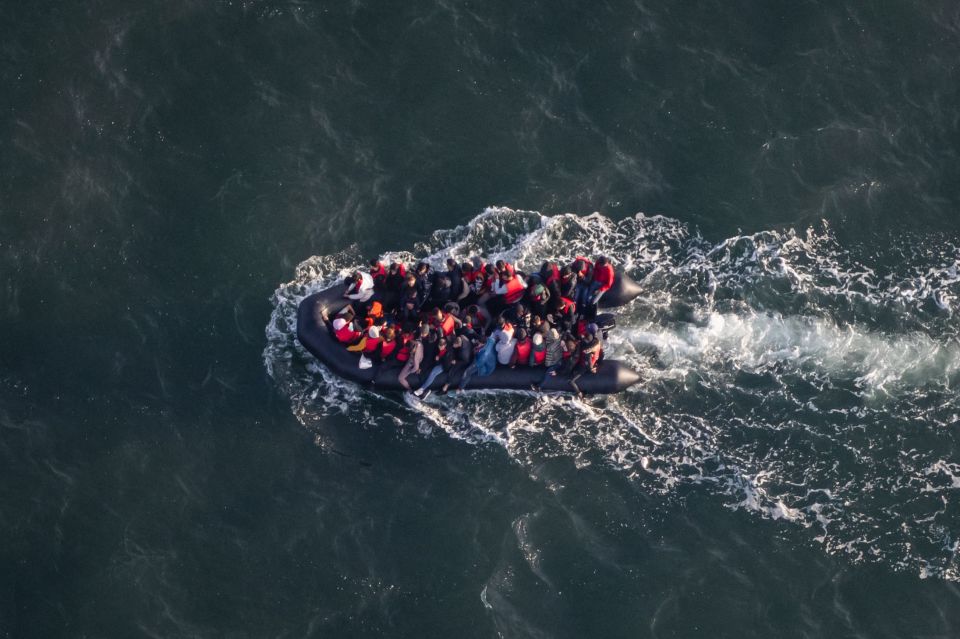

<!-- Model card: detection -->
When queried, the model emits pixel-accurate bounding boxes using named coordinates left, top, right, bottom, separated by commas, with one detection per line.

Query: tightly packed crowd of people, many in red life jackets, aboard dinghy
left=322, top=257, right=615, bottom=397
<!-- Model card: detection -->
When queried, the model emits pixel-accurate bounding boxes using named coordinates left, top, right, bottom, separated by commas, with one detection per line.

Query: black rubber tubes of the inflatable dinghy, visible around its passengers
left=297, top=273, right=640, bottom=395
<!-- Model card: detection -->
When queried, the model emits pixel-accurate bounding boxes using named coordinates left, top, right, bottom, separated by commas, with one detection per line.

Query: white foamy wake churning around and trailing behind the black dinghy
left=264, top=208, right=960, bottom=581
